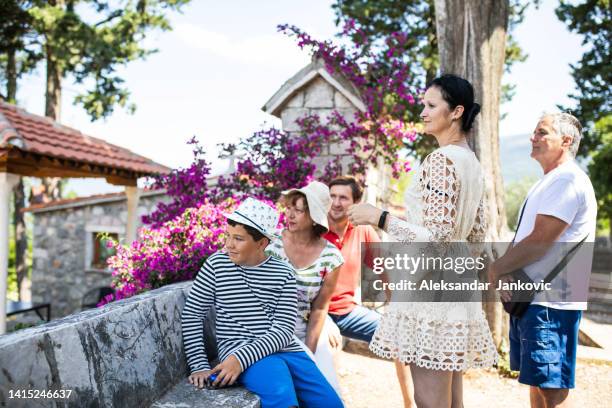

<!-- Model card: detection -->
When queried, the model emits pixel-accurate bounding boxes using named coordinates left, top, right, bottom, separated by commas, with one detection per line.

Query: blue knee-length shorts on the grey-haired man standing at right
left=510, top=305, right=582, bottom=388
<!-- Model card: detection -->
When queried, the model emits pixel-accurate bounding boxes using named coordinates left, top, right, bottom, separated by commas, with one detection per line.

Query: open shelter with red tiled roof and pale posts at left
left=0, top=101, right=170, bottom=334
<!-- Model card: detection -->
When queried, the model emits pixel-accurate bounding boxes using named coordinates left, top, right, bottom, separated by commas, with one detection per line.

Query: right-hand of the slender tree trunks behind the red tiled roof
left=42, top=45, right=62, bottom=201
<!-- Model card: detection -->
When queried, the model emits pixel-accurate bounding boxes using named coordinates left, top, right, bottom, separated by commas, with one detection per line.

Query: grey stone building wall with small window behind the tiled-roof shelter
left=32, top=193, right=166, bottom=318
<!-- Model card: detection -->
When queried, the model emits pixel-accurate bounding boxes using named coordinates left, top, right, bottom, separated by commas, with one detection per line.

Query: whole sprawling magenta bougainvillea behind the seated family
left=103, top=21, right=421, bottom=303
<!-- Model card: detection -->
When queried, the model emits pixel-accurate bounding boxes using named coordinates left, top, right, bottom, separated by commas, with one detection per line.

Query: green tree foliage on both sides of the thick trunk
left=332, top=0, right=539, bottom=157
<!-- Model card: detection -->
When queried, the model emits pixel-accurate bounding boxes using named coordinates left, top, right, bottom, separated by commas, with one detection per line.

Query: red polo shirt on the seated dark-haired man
left=323, top=223, right=380, bottom=315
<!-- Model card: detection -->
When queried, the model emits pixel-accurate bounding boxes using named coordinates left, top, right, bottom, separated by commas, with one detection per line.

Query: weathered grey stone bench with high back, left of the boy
left=0, top=282, right=259, bottom=408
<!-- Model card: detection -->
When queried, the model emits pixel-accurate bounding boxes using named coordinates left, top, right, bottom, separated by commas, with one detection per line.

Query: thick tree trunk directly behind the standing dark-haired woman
left=435, top=0, right=510, bottom=347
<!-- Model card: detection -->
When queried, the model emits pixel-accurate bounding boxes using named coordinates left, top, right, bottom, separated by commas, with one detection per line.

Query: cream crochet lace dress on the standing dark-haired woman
left=370, top=145, right=498, bottom=371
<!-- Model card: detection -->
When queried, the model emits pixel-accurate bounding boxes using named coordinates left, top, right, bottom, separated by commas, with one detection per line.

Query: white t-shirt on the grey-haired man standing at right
left=515, top=160, right=597, bottom=310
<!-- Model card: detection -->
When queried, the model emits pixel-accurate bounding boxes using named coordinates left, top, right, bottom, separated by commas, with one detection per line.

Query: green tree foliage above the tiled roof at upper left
left=0, top=0, right=189, bottom=120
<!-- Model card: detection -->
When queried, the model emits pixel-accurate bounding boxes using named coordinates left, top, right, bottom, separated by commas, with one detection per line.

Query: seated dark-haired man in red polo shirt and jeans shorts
left=323, top=176, right=415, bottom=407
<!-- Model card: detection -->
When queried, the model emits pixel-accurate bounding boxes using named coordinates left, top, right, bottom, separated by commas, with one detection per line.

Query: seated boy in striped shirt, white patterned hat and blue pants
left=181, top=198, right=343, bottom=408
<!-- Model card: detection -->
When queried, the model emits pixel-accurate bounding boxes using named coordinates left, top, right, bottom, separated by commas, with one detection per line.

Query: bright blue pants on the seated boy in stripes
left=239, top=351, right=344, bottom=408
